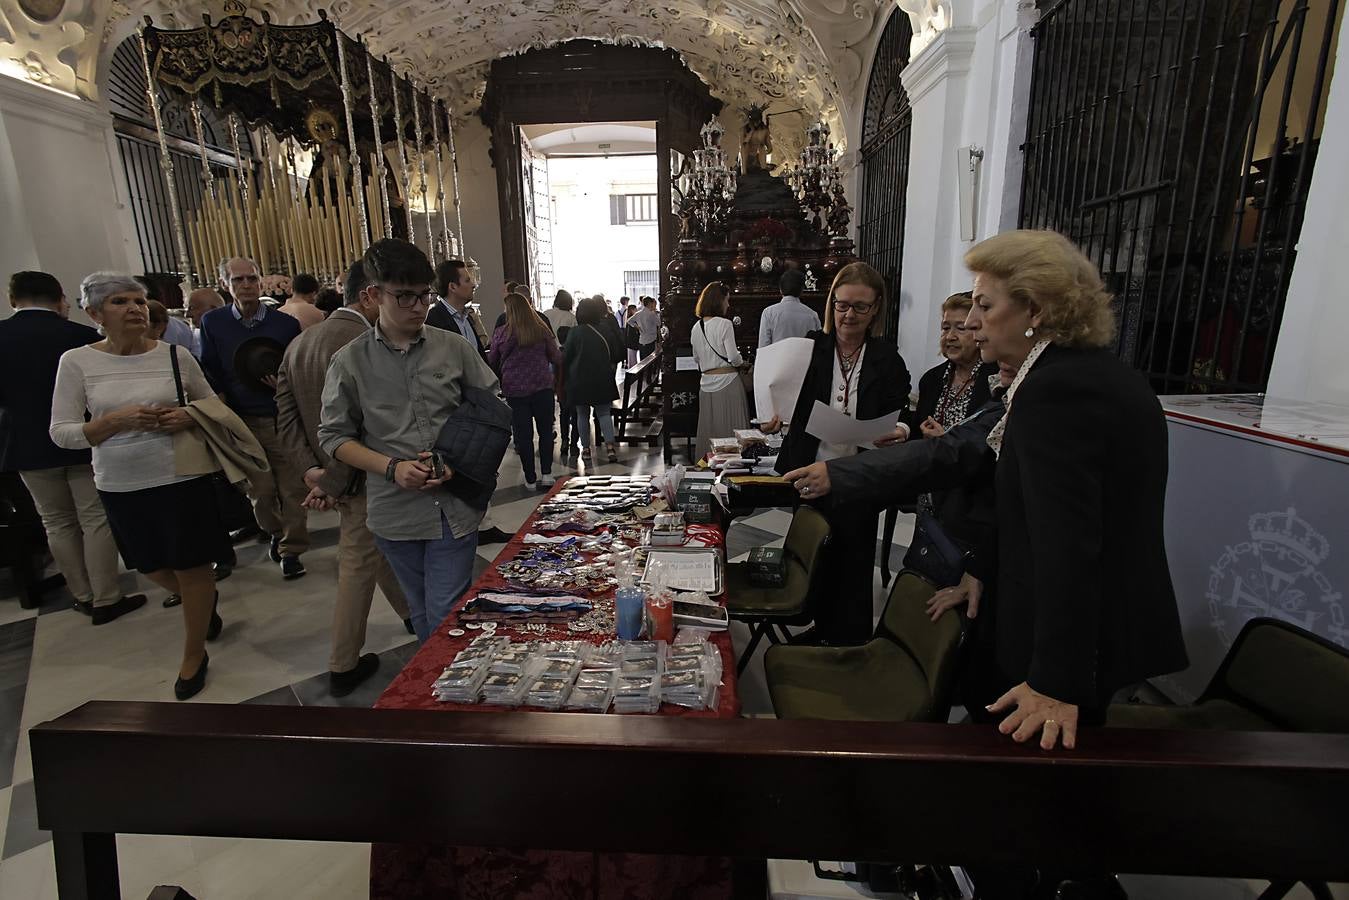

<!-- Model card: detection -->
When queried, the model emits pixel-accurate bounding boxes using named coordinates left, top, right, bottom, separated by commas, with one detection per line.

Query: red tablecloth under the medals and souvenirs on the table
left=370, top=479, right=741, bottom=900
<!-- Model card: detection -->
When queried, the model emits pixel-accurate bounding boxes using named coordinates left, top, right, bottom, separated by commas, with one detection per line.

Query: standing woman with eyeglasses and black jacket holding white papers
left=766, top=262, right=912, bottom=645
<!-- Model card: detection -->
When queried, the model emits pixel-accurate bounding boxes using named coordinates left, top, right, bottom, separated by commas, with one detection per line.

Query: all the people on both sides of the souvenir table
left=0, top=231, right=1186, bottom=804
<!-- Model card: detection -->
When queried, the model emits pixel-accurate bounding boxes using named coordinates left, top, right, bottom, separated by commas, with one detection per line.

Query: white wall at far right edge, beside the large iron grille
left=1268, top=12, right=1349, bottom=406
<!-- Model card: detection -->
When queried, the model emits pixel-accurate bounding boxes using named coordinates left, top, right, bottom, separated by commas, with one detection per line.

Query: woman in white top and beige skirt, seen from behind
left=692, top=281, right=750, bottom=459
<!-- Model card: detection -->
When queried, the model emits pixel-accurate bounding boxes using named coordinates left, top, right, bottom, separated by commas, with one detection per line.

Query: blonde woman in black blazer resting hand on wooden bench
left=965, top=231, right=1187, bottom=749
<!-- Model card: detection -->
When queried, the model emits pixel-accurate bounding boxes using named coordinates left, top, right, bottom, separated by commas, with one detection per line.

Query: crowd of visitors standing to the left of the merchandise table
left=0, top=240, right=660, bottom=699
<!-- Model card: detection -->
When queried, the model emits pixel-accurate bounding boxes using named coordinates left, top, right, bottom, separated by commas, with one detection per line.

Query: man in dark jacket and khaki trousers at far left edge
left=0, top=271, right=146, bottom=625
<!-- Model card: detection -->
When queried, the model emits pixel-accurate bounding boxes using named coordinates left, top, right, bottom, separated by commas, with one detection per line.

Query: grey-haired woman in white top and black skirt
left=51, top=273, right=229, bottom=700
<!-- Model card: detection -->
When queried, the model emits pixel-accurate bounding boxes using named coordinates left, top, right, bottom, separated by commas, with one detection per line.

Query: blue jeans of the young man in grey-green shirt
left=375, top=515, right=478, bottom=644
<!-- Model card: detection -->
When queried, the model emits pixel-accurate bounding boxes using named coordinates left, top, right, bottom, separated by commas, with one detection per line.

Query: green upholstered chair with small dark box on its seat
left=726, top=506, right=830, bottom=672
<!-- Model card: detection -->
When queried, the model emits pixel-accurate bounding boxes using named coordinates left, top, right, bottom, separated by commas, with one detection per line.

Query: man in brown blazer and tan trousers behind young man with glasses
left=277, top=260, right=411, bottom=696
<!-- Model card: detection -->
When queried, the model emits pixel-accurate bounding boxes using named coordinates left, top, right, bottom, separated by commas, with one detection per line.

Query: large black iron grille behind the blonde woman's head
left=1021, top=0, right=1341, bottom=394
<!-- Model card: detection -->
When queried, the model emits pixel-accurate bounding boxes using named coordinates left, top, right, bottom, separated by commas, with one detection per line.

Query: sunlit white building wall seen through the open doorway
left=540, top=155, right=660, bottom=306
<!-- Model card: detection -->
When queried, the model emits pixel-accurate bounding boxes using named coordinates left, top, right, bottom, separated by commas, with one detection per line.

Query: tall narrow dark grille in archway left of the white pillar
left=857, top=11, right=913, bottom=340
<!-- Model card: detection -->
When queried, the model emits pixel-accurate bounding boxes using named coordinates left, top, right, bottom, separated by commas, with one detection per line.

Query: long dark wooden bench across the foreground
left=30, top=702, right=1349, bottom=900
